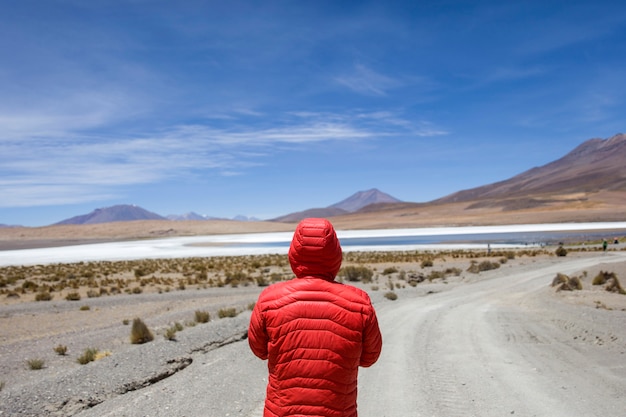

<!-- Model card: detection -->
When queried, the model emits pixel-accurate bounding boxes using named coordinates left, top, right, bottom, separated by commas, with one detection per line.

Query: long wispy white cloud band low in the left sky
left=0, top=112, right=442, bottom=207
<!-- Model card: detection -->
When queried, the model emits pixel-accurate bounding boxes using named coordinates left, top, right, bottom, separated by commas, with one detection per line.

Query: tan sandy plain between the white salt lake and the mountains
left=0, top=192, right=626, bottom=250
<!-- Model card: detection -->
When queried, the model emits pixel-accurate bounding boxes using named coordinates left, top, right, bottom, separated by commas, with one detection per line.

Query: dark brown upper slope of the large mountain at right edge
left=433, top=134, right=626, bottom=209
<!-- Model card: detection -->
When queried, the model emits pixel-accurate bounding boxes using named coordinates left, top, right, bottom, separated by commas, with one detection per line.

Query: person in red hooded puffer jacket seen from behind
left=248, top=218, right=382, bottom=417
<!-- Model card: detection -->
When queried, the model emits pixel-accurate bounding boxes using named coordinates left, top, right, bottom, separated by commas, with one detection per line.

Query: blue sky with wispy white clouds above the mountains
left=0, top=0, right=626, bottom=226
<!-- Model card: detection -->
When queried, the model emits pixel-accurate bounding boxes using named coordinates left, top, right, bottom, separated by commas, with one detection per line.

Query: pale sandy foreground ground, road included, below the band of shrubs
left=0, top=244, right=626, bottom=417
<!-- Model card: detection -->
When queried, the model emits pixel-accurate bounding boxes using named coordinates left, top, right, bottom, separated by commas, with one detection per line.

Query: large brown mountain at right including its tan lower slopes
left=324, top=134, right=626, bottom=228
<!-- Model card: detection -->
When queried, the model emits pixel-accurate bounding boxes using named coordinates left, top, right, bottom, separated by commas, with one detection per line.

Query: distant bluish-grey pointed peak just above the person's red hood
left=271, top=188, right=401, bottom=222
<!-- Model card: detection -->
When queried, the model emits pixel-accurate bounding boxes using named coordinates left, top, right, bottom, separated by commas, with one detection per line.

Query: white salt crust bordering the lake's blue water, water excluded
left=0, top=222, right=626, bottom=266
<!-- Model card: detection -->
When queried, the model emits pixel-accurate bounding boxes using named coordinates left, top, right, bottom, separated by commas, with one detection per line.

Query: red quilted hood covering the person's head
left=289, top=218, right=342, bottom=280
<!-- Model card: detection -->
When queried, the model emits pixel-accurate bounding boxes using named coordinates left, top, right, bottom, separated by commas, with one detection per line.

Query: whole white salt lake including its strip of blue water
left=0, top=222, right=626, bottom=266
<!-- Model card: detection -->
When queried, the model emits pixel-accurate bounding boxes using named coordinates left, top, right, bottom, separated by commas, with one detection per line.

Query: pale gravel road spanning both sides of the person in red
left=0, top=252, right=626, bottom=417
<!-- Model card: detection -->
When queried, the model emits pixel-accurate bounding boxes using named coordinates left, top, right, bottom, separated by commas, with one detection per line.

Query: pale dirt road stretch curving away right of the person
left=359, top=256, right=626, bottom=417
